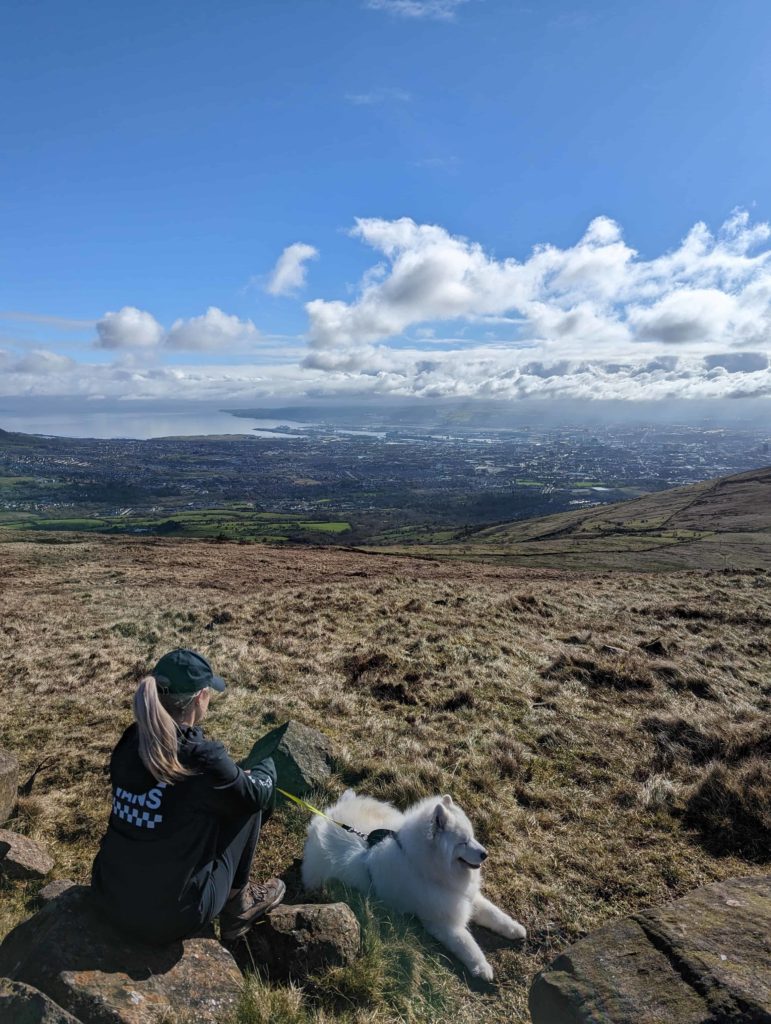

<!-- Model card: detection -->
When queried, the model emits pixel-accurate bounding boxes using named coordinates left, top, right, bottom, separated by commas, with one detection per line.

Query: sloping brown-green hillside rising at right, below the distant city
left=368, top=468, right=771, bottom=571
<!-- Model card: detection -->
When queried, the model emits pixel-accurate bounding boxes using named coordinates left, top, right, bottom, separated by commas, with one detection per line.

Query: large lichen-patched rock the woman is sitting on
left=0, top=886, right=243, bottom=1024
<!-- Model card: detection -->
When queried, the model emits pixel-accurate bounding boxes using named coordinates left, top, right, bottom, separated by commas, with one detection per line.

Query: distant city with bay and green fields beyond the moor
left=0, top=413, right=771, bottom=544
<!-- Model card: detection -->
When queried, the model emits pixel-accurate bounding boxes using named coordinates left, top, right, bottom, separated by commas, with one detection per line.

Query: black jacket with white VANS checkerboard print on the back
left=91, top=724, right=275, bottom=939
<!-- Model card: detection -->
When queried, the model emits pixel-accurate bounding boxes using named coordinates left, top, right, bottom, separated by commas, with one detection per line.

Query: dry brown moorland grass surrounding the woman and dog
left=0, top=535, right=771, bottom=1024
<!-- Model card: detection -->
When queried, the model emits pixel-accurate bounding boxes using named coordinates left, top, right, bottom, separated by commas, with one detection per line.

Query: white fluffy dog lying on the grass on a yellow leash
left=302, top=790, right=526, bottom=981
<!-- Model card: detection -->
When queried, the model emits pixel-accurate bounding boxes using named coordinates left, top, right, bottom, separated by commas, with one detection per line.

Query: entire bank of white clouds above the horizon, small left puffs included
left=0, top=211, right=771, bottom=400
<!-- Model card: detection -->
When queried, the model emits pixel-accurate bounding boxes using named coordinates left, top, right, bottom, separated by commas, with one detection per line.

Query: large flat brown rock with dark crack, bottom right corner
left=529, top=876, right=771, bottom=1024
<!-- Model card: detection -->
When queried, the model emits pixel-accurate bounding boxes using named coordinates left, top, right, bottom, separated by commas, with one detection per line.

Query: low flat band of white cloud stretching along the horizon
left=0, top=345, right=771, bottom=409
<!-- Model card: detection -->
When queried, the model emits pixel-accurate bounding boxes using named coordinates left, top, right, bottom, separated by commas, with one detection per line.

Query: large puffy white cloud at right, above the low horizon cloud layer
left=306, top=207, right=771, bottom=355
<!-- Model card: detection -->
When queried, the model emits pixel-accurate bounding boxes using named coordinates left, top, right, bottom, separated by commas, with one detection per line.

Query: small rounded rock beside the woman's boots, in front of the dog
left=240, top=903, right=361, bottom=982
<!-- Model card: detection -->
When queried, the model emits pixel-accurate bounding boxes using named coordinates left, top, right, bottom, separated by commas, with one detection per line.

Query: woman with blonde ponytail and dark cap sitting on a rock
left=91, top=649, right=286, bottom=943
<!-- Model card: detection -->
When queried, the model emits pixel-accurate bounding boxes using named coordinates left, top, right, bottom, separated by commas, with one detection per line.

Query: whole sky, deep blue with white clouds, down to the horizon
left=0, top=0, right=771, bottom=400
